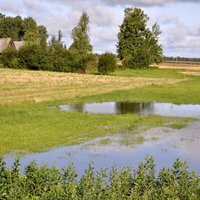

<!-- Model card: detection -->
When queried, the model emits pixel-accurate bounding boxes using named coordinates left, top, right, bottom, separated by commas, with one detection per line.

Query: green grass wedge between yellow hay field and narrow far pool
left=74, top=77, right=200, bottom=104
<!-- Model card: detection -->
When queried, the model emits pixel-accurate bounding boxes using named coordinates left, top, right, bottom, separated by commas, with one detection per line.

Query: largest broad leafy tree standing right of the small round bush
left=117, top=8, right=162, bottom=68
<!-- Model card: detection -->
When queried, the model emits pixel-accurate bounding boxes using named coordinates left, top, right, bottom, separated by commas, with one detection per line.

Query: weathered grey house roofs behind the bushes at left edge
left=0, top=38, right=23, bottom=54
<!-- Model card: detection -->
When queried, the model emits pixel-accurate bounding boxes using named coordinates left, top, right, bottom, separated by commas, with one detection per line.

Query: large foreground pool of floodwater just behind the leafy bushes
left=4, top=121, right=200, bottom=175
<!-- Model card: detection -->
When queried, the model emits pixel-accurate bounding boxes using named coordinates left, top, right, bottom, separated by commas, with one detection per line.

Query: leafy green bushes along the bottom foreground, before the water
left=0, top=157, right=200, bottom=200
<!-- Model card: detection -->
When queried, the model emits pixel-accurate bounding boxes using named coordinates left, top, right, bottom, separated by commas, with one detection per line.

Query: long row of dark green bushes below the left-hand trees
left=2, top=44, right=96, bottom=73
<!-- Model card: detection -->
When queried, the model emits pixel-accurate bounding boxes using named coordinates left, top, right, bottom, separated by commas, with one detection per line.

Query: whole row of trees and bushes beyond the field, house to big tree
left=0, top=8, right=162, bottom=74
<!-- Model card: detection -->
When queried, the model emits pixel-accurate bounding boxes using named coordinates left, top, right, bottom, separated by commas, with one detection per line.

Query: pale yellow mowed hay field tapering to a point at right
left=0, top=68, right=184, bottom=106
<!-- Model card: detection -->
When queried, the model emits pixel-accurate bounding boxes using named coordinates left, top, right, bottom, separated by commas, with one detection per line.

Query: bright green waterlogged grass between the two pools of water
left=0, top=103, right=184, bottom=154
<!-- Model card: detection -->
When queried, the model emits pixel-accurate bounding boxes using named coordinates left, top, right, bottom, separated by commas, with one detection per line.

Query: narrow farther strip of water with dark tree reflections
left=59, top=102, right=200, bottom=118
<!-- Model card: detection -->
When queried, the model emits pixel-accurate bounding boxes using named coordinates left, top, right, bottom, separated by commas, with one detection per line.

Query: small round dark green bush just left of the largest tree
left=98, top=53, right=116, bottom=75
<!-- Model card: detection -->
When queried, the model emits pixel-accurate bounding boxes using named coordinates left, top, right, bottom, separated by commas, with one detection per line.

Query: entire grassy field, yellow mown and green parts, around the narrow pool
left=0, top=69, right=200, bottom=154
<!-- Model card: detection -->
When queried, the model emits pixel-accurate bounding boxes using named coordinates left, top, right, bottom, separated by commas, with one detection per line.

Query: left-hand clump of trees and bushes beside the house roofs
left=0, top=12, right=95, bottom=73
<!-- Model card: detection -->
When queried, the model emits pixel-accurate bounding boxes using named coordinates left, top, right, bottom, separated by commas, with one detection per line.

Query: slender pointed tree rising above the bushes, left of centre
left=70, top=12, right=92, bottom=54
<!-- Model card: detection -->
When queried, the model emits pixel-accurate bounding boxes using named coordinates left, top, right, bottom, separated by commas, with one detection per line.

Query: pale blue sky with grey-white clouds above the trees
left=0, top=0, right=200, bottom=57
